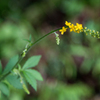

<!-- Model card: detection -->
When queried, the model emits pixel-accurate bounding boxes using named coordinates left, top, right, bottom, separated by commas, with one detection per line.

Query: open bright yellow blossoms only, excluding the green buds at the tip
left=59, top=21, right=83, bottom=35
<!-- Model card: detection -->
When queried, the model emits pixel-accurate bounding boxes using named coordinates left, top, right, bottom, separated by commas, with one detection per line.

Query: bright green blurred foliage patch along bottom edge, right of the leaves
left=39, top=82, right=92, bottom=100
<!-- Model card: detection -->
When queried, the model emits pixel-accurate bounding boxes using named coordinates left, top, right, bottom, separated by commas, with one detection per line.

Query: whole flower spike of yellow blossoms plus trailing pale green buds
left=59, top=21, right=100, bottom=38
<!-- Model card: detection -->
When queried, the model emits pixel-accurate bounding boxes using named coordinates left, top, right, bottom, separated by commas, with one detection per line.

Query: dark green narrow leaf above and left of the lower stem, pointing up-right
left=3, top=55, right=18, bottom=74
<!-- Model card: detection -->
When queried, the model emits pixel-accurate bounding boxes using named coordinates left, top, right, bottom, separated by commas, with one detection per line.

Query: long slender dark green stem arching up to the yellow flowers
left=0, top=28, right=61, bottom=81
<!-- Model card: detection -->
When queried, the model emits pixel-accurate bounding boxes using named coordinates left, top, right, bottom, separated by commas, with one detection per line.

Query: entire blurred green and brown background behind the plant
left=0, top=0, right=100, bottom=100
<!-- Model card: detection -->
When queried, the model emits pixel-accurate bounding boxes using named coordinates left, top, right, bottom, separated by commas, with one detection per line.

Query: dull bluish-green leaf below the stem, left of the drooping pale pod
left=6, top=74, right=23, bottom=89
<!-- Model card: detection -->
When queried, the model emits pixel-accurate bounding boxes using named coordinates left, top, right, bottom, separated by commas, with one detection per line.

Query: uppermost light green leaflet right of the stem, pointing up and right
left=23, top=55, right=41, bottom=69
